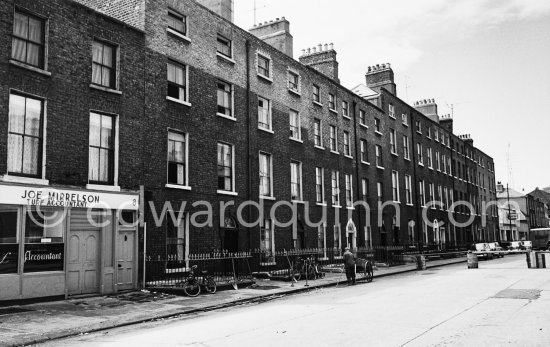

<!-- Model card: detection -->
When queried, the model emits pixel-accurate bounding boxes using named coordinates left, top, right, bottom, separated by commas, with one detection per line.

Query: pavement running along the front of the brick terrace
left=0, top=257, right=472, bottom=346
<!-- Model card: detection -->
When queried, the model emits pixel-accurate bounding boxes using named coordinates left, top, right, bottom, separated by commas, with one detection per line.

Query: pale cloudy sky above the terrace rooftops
left=234, top=0, right=550, bottom=192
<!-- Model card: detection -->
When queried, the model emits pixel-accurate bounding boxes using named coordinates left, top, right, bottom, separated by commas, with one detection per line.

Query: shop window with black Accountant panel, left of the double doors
left=24, top=208, right=66, bottom=273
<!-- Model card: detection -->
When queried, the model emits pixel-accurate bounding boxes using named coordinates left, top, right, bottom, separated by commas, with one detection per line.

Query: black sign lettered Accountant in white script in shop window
left=24, top=243, right=65, bottom=272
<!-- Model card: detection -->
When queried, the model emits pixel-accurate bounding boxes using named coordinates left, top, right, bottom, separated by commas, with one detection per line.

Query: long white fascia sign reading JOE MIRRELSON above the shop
left=0, top=184, right=139, bottom=210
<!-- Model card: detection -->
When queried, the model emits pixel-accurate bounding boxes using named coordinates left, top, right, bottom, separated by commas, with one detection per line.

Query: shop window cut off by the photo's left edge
left=0, top=205, right=19, bottom=274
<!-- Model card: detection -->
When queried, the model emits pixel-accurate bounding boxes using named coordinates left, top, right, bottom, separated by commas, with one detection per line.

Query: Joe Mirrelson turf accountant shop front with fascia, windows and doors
left=0, top=183, right=139, bottom=301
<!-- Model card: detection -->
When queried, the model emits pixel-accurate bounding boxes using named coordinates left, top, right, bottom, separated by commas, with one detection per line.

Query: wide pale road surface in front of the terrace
left=41, top=256, right=550, bottom=347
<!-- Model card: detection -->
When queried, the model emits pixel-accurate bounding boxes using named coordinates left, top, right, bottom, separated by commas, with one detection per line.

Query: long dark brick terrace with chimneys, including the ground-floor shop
left=0, top=0, right=500, bottom=300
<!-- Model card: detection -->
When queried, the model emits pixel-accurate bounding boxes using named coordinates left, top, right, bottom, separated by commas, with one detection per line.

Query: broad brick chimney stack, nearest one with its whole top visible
left=249, top=17, right=294, bottom=57
